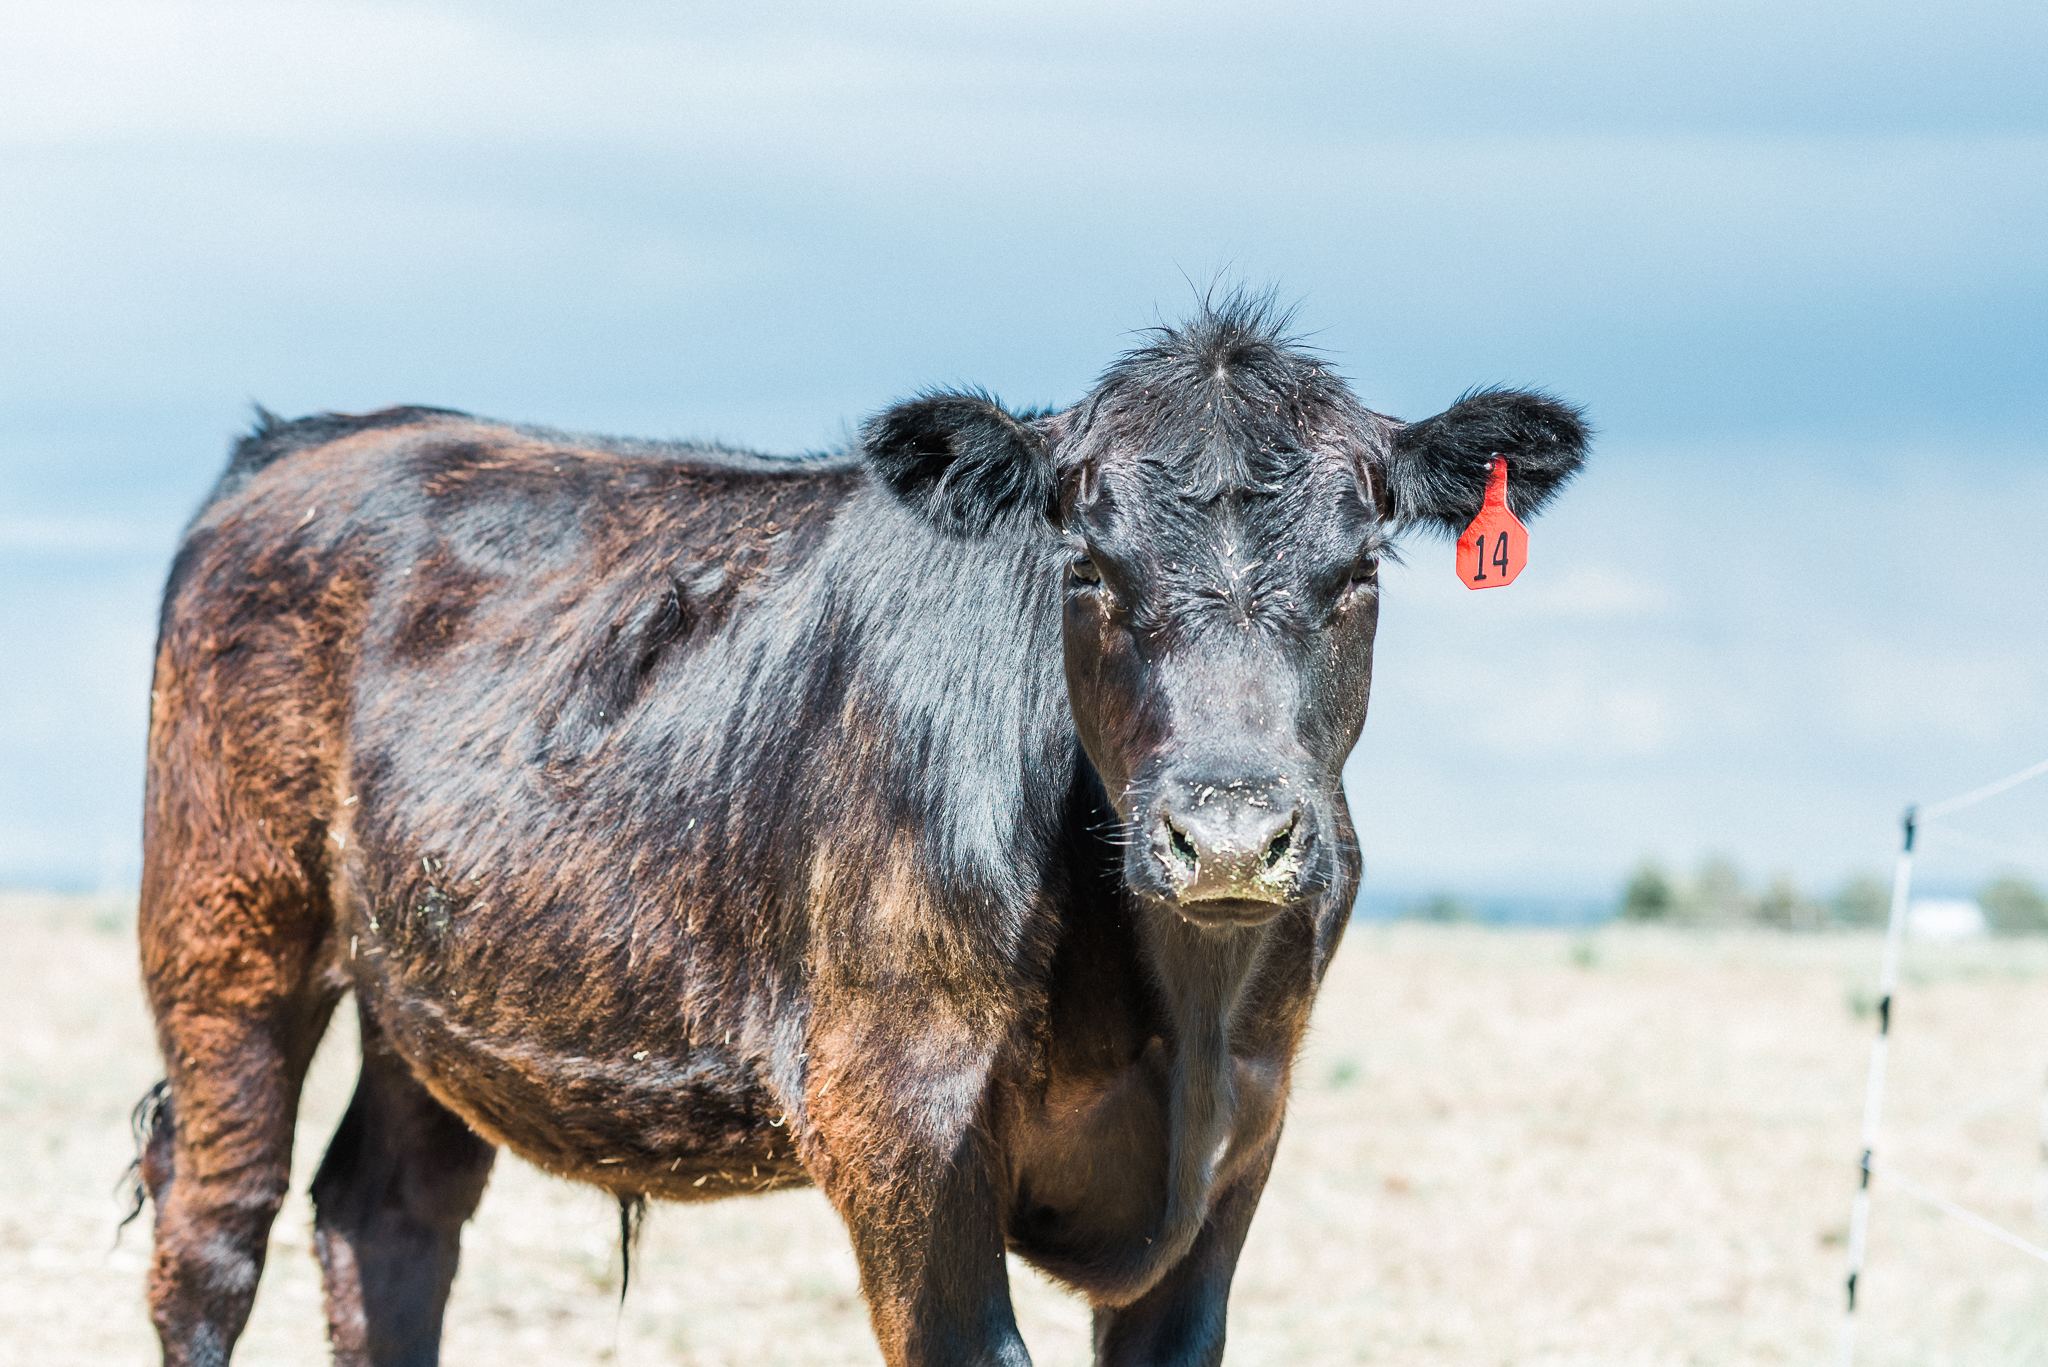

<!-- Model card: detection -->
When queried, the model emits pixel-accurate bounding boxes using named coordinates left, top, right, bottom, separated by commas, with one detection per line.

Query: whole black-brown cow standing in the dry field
left=139, top=297, right=1587, bottom=1365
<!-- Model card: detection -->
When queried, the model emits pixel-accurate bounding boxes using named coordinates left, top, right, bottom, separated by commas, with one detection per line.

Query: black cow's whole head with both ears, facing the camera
left=862, top=303, right=1587, bottom=924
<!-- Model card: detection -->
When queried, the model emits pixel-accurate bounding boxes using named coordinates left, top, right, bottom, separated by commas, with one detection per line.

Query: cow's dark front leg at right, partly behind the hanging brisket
left=1096, top=1135, right=1278, bottom=1367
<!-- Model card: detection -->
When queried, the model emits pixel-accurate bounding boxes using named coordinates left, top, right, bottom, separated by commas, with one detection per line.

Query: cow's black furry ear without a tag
left=860, top=393, right=1055, bottom=537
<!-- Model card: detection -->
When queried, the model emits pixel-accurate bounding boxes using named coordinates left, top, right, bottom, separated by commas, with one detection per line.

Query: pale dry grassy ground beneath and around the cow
left=0, top=896, right=2048, bottom=1367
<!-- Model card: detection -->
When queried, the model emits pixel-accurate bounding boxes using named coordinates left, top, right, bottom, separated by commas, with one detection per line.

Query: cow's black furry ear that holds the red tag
left=1386, top=389, right=1591, bottom=535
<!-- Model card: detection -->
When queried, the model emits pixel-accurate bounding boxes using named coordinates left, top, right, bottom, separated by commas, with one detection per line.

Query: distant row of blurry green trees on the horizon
left=1618, top=855, right=2048, bottom=935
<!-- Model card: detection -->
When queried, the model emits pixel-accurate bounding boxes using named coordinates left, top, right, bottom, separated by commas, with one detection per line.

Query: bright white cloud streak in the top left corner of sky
left=0, top=0, right=1048, bottom=154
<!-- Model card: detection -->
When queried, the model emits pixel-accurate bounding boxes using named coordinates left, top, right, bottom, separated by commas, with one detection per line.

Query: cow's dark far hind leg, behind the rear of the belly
left=313, top=1010, right=496, bottom=1367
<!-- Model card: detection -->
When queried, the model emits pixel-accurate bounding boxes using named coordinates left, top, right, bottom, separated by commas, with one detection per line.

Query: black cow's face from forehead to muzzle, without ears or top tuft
left=1061, top=401, right=1386, bottom=922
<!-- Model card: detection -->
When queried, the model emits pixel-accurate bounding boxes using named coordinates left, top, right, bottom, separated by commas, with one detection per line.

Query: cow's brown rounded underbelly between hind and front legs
left=358, top=967, right=809, bottom=1201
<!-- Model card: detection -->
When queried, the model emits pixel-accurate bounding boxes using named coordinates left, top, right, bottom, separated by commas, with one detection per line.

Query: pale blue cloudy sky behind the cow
left=0, top=0, right=2048, bottom=898
